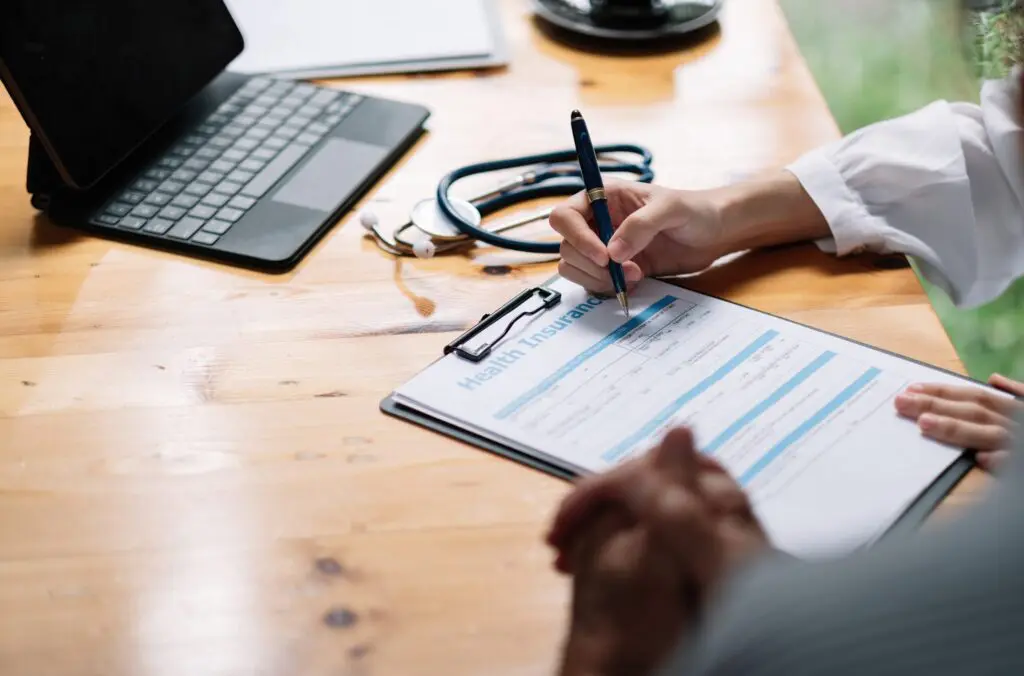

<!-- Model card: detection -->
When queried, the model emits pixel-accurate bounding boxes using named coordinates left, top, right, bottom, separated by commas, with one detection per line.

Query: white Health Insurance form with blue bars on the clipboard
left=395, top=280, right=965, bottom=556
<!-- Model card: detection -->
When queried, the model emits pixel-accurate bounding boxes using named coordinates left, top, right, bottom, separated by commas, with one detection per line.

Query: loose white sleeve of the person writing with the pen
left=787, top=77, right=1024, bottom=307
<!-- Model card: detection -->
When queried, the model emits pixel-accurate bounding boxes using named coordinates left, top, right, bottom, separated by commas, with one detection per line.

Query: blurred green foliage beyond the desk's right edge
left=780, top=0, right=1024, bottom=379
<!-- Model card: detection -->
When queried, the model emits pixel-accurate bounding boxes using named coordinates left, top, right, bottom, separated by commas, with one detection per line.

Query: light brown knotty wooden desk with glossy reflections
left=0, top=0, right=987, bottom=676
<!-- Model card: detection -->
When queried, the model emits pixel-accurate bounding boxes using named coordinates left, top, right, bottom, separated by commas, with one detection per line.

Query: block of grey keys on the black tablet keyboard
left=91, top=78, right=361, bottom=246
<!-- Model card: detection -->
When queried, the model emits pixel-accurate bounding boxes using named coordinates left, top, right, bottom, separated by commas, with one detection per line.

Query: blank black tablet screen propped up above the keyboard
left=0, top=0, right=243, bottom=187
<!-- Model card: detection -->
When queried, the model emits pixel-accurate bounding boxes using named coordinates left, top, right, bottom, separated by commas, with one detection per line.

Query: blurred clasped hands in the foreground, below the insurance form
left=548, top=429, right=768, bottom=676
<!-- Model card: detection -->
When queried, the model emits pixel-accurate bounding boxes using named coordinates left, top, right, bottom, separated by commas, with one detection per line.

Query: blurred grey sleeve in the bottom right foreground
left=659, top=449, right=1024, bottom=676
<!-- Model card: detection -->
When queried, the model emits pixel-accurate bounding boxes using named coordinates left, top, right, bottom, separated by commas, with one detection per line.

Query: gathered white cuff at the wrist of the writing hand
left=786, top=146, right=870, bottom=256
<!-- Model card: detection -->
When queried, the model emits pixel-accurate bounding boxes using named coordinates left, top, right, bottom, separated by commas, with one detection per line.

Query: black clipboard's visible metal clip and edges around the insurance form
left=380, top=276, right=985, bottom=546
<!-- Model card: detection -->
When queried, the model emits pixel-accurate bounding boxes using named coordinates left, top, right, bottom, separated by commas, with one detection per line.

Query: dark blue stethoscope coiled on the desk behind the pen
left=359, top=144, right=654, bottom=258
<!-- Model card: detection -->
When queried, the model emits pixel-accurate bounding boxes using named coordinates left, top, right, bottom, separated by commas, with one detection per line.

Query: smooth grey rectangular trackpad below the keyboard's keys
left=271, top=138, right=387, bottom=212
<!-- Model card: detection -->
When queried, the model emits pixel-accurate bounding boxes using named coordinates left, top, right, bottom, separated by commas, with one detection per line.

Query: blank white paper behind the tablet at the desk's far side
left=226, top=0, right=495, bottom=73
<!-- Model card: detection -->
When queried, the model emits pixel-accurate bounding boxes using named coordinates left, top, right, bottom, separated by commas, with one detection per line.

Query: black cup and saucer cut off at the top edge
left=534, top=0, right=724, bottom=43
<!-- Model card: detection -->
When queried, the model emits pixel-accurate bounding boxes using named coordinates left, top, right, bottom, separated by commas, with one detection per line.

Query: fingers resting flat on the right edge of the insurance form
left=896, top=374, right=1024, bottom=471
